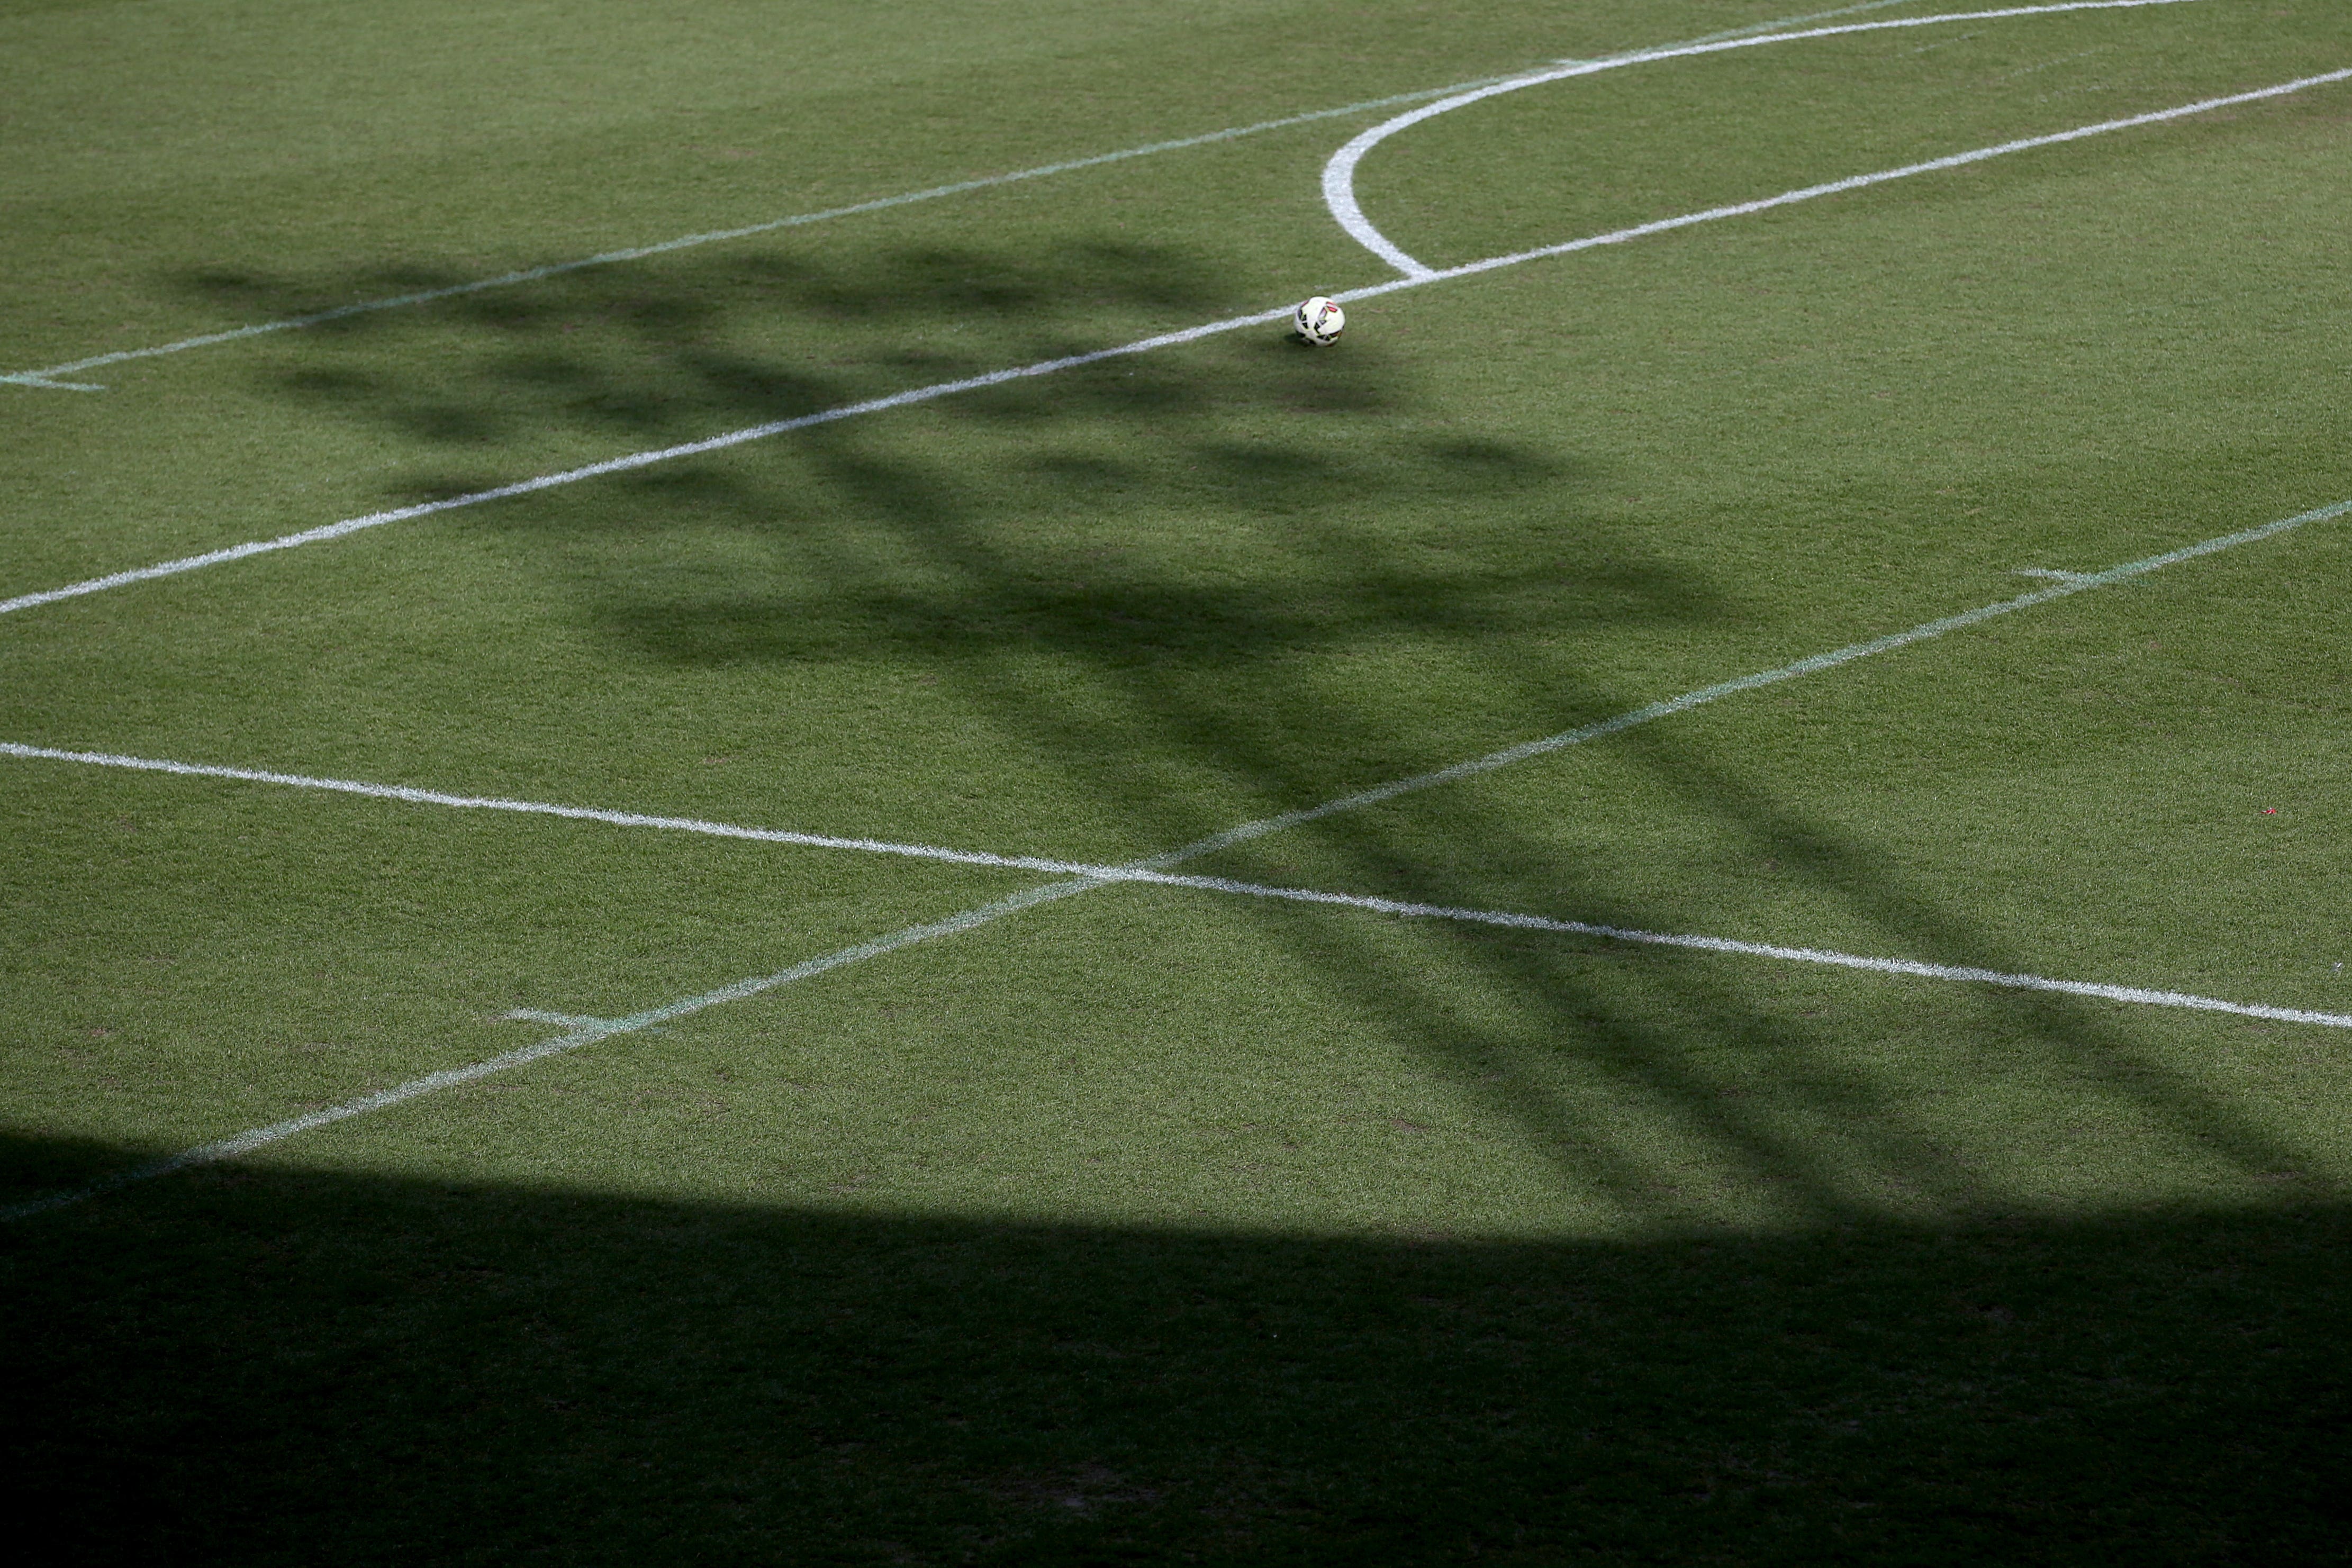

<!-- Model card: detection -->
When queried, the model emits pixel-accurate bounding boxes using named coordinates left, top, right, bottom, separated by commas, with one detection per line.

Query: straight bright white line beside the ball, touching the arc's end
left=0, top=52, right=2352, bottom=616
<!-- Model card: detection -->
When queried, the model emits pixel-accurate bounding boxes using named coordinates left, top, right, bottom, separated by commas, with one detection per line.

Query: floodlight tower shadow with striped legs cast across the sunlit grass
left=216, top=236, right=2291, bottom=1225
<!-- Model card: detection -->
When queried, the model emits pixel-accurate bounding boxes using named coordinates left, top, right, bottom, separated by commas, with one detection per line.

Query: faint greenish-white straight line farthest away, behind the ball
left=0, top=0, right=1914, bottom=393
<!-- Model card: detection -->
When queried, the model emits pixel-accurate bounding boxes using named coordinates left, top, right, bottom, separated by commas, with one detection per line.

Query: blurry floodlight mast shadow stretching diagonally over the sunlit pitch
left=161, top=240, right=2324, bottom=1225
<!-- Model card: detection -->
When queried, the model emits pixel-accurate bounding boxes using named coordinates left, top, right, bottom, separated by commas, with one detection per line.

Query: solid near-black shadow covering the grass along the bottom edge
left=0, top=1140, right=2352, bottom=1563
